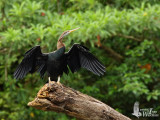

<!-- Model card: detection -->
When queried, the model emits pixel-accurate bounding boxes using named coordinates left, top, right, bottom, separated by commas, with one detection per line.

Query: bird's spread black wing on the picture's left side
left=14, top=46, right=48, bottom=79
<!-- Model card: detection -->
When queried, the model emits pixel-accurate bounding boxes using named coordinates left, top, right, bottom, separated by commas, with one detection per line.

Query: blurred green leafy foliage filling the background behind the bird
left=0, top=0, right=160, bottom=120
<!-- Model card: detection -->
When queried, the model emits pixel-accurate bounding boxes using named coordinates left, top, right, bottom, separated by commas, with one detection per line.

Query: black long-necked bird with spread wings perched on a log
left=14, top=28, right=105, bottom=83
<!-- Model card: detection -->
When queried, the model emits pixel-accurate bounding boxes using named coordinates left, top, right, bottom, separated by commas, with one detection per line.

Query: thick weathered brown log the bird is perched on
left=28, top=81, right=131, bottom=120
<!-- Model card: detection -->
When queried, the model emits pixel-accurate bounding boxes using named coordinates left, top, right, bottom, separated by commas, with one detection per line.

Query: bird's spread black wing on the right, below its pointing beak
left=66, top=44, right=105, bottom=76
